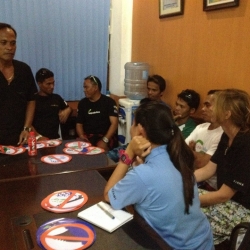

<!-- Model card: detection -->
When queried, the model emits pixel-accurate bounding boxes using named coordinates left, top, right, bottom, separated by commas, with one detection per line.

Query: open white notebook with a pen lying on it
left=77, top=201, right=133, bottom=233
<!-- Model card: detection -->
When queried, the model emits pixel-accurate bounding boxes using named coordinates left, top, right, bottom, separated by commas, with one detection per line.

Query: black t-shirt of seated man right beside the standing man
left=33, top=94, right=68, bottom=139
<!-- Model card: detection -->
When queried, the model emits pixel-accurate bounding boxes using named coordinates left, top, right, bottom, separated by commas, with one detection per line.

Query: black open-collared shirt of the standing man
left=0, top=60, right=37, bottom=145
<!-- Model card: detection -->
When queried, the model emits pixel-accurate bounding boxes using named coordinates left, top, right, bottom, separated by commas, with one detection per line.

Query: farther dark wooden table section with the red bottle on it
left=0, top=140, right=116, bottom=182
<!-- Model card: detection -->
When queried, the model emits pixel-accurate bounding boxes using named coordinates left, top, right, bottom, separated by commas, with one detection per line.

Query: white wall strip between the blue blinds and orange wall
left=109, top=0, right=133, bottom=96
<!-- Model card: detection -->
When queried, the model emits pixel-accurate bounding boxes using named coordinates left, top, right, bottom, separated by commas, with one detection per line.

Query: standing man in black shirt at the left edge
left=0, top=23, right=37, bottom=146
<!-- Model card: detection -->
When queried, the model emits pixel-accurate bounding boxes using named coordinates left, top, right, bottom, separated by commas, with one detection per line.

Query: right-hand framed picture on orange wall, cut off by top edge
left=203, top=0, right=240, bottom=11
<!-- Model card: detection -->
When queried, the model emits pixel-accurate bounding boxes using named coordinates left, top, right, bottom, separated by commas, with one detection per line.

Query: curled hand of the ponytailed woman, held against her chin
left=126, top=136, right=151, bottom=159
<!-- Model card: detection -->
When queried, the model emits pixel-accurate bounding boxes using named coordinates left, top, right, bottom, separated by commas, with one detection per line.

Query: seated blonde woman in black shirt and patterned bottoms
left=195, top=89, right=250, bottom=244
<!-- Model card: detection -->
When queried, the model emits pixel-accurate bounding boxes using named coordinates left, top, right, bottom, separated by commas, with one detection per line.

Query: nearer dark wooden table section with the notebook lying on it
left=0, top=170, right=159, bottom=250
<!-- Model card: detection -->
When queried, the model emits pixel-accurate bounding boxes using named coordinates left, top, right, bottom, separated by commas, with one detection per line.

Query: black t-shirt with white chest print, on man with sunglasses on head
left=76, top=95, right=118, bottom=135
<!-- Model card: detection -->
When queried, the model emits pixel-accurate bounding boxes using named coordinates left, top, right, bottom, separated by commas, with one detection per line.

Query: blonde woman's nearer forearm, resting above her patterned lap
left=199, top=184, right=237, bottom=207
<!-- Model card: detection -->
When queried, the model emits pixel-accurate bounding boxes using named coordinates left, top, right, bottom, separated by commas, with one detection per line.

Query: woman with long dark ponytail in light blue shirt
left=104, top=102, right=214, bottom=250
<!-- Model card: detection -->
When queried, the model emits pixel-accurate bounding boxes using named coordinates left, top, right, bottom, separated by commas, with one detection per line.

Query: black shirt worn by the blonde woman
left=211, top=131, right=250, bottom=209
